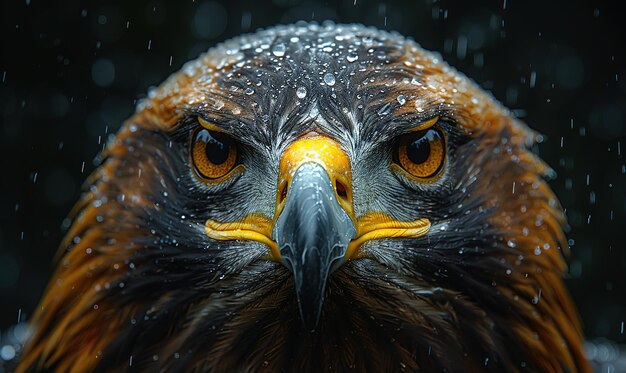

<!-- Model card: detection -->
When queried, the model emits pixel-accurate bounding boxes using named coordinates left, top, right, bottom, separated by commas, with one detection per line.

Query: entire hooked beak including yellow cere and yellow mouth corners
left=206, top=136, right=430, bottom=331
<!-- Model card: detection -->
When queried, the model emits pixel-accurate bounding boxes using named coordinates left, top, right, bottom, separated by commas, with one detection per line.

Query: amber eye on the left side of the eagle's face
left=191, top=128, right=237, bottom=179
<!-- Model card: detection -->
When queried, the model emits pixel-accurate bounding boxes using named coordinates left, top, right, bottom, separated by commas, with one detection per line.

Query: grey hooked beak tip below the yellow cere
left=273, top=162, right=356, bottom=330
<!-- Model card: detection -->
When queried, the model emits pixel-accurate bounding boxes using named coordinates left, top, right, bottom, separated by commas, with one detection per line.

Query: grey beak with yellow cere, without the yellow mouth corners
left=272, top=136, right=356, bottom=330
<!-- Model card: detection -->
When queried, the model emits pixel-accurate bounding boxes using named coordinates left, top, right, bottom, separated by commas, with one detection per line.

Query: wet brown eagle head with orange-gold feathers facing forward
left=21, top=24, right=588, bottom=371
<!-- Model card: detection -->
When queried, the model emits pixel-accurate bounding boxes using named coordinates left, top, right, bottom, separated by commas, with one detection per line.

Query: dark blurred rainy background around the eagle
left=0, top=0, right=626, bottom=360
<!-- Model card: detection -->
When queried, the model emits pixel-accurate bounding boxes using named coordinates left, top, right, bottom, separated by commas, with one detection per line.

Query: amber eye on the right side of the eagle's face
left=396, top=128, right=446, bottom=179
